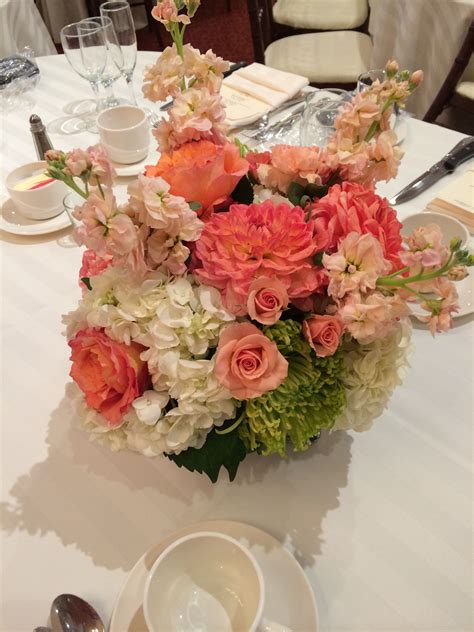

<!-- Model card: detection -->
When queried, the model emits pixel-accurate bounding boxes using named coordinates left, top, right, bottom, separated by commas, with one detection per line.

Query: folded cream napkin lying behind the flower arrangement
left=221, top=64, right=309, bottom=127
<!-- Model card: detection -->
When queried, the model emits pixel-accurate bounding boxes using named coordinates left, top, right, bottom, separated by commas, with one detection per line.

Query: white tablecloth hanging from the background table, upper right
left=369, top=0, right=474, bottom=118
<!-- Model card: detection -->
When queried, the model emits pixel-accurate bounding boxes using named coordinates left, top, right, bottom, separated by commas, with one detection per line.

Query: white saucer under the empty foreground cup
left=109, top=520, right=319, bottom=632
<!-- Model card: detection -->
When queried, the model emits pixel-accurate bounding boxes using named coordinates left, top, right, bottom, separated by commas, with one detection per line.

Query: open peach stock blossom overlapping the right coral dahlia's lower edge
left=323, top=232, right=391, bottom=298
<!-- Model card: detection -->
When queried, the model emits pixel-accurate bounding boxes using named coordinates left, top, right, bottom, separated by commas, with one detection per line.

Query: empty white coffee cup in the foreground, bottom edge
left=143, top=531, right=290, bottom=632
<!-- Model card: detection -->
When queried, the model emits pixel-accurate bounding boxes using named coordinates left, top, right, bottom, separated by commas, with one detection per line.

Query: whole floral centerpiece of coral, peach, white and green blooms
left=47, top=0, right=473, bottom=481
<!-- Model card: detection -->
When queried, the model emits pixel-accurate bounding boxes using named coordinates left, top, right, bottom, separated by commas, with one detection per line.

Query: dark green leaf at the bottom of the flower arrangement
left=166, top=428, right=247, bottom=483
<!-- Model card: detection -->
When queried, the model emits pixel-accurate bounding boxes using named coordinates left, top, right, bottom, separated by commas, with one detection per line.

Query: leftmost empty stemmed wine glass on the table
left=60, top=22, right=107, bottom=129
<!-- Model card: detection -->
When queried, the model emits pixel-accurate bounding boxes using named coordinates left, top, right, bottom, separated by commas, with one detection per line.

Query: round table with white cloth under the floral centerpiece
left=0, top=52, right=473, bottom=632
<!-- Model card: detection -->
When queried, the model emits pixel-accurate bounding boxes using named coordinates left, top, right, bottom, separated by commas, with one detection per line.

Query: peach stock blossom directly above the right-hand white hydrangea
left=338, top=291, right=408, bottom=344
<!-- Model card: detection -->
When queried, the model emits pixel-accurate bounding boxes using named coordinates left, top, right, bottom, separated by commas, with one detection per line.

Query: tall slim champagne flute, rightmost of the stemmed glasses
left=100, top=0, right=137, bottom=105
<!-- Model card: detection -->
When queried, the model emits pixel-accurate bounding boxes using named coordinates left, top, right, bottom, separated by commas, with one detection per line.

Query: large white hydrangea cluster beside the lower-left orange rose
left=68, top=268, right=235, bottom=456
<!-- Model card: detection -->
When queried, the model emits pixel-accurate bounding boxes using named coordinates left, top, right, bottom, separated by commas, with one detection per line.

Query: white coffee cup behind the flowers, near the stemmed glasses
left=97, top=105, right=150, bottom=165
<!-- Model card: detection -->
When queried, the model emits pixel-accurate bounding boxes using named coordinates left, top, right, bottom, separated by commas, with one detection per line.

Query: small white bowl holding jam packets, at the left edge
left=5, top=160, right=68, bottom=220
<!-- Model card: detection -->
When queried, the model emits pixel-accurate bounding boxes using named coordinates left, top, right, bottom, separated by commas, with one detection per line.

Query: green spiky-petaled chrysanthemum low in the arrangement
left=238, top=320, right=346, bottom=456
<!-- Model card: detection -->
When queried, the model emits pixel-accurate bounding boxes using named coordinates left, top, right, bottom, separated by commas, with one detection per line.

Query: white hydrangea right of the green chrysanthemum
left=334, top=320, right=413, bottom=431
